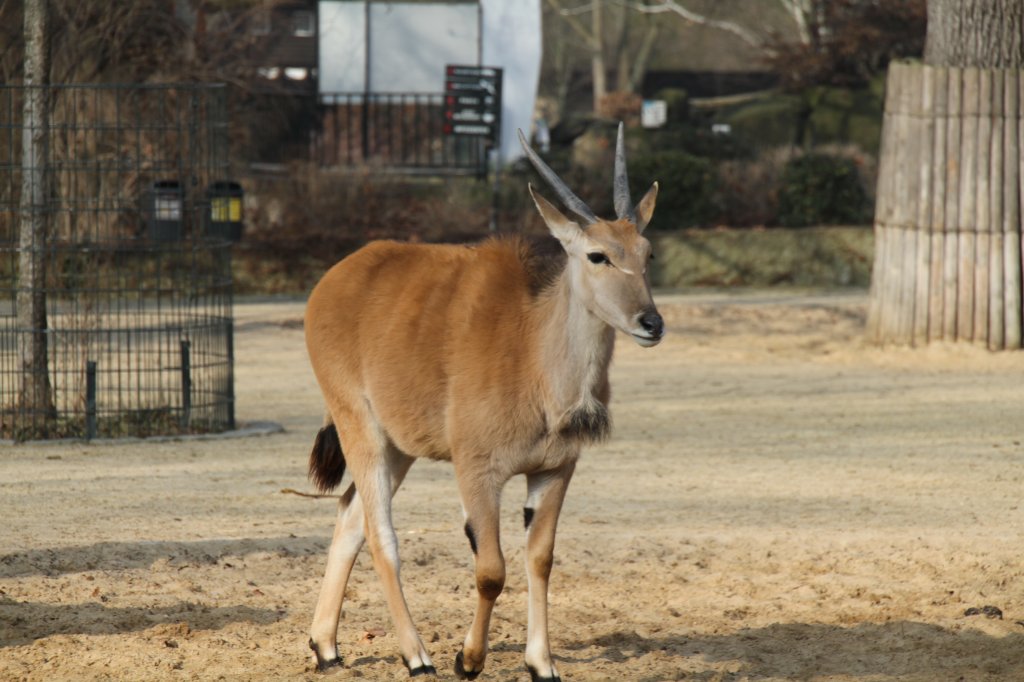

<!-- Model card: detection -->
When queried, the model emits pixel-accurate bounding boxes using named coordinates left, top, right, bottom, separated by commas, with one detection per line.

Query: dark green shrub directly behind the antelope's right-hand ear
left=630, top=152, right=717, bottom=229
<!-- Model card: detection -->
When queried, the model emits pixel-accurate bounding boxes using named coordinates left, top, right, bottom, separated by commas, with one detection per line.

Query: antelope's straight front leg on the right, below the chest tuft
left=523, top=463, right=575, bottom=682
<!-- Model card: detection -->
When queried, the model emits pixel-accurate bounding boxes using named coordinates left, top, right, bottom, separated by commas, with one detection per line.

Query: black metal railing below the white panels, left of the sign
left=314, top=92, right=486, bottom=175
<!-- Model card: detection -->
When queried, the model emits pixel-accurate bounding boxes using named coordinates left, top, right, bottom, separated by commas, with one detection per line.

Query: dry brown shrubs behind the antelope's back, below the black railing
left=233, top=164, right=491, bottom=293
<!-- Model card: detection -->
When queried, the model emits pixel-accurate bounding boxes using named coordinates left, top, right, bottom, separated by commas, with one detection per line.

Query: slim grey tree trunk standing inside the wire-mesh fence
left=15, top=0, right=54, bottom=437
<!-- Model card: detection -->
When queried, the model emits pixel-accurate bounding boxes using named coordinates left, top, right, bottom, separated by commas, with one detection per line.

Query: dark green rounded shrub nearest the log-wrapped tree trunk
left=778, top=154, right=870, bottom=227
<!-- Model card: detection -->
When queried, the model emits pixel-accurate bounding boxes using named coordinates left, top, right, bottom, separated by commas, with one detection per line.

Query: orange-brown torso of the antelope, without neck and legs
left=305, top=236, right=550, bottom=459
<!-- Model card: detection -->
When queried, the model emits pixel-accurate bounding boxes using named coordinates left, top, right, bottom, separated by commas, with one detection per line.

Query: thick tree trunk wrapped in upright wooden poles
left=868, top=0, right=1024, bottom=349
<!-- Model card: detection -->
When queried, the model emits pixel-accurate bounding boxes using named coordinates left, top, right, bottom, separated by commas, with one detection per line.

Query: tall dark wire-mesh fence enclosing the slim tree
left=0, top=85, right=234, bottom=440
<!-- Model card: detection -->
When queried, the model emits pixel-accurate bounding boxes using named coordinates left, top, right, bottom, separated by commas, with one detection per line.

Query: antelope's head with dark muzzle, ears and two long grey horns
left=519, top=123, right=665, bottom=347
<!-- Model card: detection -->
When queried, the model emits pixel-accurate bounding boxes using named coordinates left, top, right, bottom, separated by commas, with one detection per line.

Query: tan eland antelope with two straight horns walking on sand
left=305, top=124, right=665, bottom=680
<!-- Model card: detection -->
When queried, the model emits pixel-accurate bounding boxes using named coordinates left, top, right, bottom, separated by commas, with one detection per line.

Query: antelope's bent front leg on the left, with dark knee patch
left=455, top=472, right=505, bottom=680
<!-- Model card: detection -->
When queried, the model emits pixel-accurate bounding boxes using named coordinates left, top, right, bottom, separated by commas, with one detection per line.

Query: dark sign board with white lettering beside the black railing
left=444, top=65, right=502, bottom=142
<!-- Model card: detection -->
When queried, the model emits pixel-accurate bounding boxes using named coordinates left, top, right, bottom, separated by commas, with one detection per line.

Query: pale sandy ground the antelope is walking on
left=0, top=292, right=1024, bottom=681
